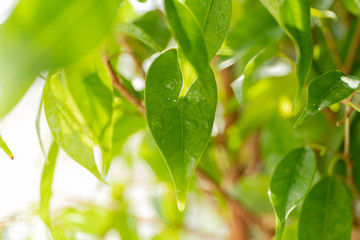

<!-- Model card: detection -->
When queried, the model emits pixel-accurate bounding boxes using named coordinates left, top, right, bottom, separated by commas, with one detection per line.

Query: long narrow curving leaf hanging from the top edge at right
left=280, top=0, right=313, bottom=94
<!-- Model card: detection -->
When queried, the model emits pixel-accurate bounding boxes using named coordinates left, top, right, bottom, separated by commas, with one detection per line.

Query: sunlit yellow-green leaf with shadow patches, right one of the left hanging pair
left=66, top=54, right=113, bottom=174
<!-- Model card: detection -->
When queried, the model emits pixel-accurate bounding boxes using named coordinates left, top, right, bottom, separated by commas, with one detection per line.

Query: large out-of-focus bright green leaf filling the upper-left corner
left=0, top=0, right=120, bottom=116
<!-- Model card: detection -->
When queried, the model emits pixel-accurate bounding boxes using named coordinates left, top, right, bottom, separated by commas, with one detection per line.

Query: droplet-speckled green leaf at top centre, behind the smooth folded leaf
left=185, top=0, right=232, bottom=61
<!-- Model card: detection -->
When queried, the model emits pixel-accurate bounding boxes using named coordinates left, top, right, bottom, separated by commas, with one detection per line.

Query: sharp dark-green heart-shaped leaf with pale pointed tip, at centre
left=145, top=49, right=217, bottom=211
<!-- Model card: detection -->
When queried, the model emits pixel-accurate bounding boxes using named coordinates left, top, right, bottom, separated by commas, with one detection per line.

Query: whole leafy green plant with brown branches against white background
left=0, top=0, right=360, bottom=240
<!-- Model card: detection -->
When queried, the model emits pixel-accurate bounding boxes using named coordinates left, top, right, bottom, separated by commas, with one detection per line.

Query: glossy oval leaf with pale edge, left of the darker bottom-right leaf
left=269, top=147, right=316, bottom=240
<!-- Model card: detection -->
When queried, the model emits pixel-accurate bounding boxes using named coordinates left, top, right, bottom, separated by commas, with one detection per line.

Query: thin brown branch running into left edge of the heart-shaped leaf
left=103, top=56, right=145, bottom=116
